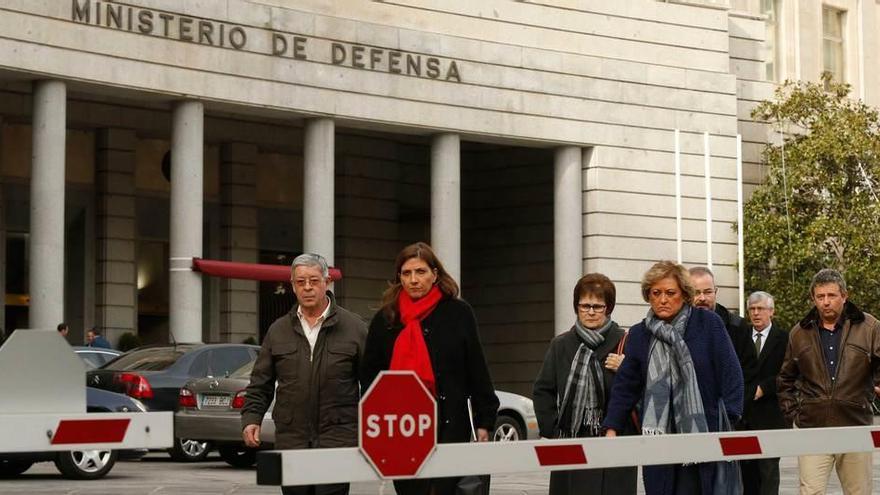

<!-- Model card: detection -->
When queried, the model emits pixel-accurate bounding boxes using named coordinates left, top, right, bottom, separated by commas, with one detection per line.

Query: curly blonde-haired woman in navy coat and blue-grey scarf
left=604, top=261, right=743, bottom=495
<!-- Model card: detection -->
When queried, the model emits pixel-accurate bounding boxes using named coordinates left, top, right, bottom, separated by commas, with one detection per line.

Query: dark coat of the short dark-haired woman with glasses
left=532, top=323, right=637, bottom=495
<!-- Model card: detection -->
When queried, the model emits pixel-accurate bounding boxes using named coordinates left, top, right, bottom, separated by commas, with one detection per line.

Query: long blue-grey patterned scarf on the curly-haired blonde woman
left=642, top=305, right=709, bottom=435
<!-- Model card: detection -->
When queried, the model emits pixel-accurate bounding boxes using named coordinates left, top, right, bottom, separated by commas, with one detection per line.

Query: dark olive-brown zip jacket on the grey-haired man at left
left=241, top=292, right=367, bottom=449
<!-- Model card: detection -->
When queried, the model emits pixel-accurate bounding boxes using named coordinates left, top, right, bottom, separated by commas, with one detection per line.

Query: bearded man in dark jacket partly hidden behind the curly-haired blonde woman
left=688, top=266, right=758, bottom=382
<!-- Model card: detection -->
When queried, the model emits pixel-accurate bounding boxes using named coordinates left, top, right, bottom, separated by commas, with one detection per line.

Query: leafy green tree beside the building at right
left=743, top=78, right=880, bottom=327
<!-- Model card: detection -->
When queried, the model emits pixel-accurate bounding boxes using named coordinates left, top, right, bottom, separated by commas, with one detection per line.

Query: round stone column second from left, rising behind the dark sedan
left=168, top=101, right=205, bottom=343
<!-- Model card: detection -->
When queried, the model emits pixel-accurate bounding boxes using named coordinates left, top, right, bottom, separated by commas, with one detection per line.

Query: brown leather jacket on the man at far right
left=776, top=301, right=880, bottom=428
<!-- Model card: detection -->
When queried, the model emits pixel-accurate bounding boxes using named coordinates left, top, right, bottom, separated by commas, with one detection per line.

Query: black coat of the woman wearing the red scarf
left=361, top=297, right=499, bottom=443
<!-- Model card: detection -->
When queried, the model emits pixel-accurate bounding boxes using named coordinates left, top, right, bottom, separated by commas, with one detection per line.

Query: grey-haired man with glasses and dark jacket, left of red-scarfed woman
left=241, top=254, right=367, bottom=495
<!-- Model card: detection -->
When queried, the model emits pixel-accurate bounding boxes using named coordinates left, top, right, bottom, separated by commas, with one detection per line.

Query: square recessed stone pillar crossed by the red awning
left=220, top=143, right=260, bottom=342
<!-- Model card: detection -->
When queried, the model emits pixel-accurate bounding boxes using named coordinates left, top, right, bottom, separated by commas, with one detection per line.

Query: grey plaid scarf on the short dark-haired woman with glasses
left=559, top=318, right=614, bottom=438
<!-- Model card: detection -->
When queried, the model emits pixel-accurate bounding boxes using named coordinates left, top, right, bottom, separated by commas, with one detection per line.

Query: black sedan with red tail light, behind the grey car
left=86, top=344, right=260, bottom=461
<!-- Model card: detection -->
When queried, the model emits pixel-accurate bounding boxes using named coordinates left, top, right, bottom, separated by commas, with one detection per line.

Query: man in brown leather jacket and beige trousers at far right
left=776, top=268, right=880, bottom=494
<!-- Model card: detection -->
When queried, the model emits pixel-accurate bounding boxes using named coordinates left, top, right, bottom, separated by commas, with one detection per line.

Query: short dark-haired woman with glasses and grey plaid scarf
left=533, top=273, right=636, bottom=495
